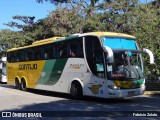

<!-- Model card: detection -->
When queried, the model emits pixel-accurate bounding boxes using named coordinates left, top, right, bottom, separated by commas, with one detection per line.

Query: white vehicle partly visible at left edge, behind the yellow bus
left=0, top=57, right=7, bottom=83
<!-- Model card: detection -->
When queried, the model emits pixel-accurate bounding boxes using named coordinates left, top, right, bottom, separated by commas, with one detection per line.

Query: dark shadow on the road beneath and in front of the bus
left=1, top=85, right=160, bottom=120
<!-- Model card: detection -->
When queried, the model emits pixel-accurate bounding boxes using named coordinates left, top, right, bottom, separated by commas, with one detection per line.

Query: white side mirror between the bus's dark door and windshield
left=103, top=46, right=114, bottom=64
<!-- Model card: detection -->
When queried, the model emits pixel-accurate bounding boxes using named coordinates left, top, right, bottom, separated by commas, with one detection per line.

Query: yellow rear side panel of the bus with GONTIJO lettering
left=7, top=60, right=45, bottom=88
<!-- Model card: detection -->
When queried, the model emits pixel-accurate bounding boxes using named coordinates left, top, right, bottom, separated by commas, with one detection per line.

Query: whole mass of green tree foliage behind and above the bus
left=0, top=0, right=160, bottom=74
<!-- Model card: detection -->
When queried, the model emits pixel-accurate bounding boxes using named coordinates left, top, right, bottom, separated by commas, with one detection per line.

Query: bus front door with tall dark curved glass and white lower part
left=85, top=36, right=105, bottom=94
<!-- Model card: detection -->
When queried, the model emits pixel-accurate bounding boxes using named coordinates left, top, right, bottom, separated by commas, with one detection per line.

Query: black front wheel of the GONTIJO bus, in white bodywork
left=70, top=81, right=83, bottom=99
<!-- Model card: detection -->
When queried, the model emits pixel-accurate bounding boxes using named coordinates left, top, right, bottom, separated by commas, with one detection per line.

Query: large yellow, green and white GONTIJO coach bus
left=7, top=32, right=154, bottom=99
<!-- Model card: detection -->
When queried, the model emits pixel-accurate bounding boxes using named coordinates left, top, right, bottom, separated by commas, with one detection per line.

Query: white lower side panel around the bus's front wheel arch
left=53, top=58, right=107, bottom=97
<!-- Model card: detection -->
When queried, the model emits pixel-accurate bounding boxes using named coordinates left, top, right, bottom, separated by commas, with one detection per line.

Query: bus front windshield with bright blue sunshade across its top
left=102, top=37, right=143, bottom=80
